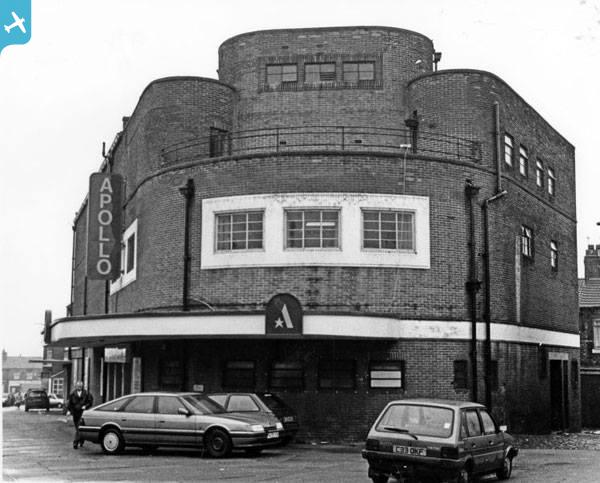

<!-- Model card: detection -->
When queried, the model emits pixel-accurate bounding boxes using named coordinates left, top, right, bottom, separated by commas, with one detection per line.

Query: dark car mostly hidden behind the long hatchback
left=207, top=392, right=299, bottom=445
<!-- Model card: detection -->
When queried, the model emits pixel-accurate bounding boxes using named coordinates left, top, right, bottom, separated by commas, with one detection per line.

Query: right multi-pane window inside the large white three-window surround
left=363, top=211, right=415, bottom=250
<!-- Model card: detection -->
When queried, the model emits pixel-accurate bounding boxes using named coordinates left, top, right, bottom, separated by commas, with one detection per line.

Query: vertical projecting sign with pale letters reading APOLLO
left=87, top=173, right=123, bottom=280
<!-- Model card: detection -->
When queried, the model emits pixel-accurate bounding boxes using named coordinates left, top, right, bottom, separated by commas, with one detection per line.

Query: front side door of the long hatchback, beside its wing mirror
left=156, top=395, right=198, bottom=446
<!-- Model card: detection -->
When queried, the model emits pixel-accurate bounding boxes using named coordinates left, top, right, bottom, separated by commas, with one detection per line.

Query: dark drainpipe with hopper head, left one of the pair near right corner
left=465, top=179, right=481, bottom=401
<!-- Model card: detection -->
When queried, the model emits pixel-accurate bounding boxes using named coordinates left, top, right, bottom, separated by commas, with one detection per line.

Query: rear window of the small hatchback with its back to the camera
left=376, top=404, right=454, bottom=438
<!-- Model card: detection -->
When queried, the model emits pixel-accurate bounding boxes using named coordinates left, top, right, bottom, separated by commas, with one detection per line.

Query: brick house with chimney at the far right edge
left=579, top=245, right=600, bottom=428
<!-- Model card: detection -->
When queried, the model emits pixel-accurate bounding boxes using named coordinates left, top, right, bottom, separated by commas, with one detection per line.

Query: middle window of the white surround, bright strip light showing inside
left=286, top=210, right=339, bottom=248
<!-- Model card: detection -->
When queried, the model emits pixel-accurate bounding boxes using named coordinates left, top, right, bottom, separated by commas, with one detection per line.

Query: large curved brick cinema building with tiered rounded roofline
left=51, top=27, right=580, bottom=440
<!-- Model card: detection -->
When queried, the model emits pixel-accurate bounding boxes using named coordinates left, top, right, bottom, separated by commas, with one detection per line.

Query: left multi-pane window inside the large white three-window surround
left=216, top=211, right=263, bottom=251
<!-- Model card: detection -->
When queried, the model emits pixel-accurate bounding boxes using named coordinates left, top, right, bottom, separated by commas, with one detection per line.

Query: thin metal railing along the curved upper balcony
left=161, top=126, right=482, bottom=163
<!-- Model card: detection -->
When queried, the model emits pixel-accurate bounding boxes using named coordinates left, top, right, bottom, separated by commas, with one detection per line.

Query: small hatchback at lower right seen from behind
left=362, top=399, right=518, bottom=483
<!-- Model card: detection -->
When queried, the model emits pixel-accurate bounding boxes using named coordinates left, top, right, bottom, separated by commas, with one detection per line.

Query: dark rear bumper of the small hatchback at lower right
left=362, top=449, right=465, bottom=476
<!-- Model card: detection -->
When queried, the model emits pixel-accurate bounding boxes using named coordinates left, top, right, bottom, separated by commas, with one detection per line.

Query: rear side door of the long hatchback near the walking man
left=113, top=395, right=156, bottom=444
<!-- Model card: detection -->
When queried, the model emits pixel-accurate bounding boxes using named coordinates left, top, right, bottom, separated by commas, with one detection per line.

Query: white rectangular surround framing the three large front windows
left=200, top=192, right=430, bottom=270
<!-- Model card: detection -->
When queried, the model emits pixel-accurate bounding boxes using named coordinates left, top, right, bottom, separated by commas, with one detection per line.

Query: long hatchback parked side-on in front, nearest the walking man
left=79, top=392, right=283, bottom=458
